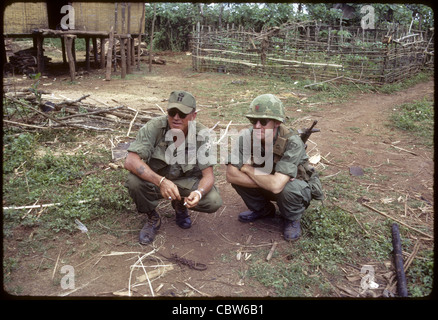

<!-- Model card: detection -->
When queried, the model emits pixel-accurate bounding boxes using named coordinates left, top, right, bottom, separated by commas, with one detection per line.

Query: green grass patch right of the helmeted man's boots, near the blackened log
left=247, top=206, right=392, bottom=297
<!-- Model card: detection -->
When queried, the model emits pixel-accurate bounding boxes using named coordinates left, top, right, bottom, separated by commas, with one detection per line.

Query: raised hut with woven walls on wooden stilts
left=3, top=0, right=145, bottom=80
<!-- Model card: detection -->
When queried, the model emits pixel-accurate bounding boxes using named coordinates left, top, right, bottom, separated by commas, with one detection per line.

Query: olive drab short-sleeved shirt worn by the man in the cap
left=128, top=116, right=214, bottom=189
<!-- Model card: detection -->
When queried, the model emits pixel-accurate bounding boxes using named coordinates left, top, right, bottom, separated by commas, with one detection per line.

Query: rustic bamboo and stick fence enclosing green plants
left=190, top=21, right=434, bottom=84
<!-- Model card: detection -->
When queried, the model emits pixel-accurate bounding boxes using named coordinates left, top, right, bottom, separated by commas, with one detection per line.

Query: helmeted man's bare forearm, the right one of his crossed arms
left=240, top=164, right=290, bottom=194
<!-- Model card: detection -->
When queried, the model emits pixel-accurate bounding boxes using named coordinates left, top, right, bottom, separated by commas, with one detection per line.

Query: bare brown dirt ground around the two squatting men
left=3, top=48, right=434, bottom=297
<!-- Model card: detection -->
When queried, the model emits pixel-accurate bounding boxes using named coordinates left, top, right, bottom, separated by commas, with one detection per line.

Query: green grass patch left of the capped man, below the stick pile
left=3, top=132, right=130, bottom=232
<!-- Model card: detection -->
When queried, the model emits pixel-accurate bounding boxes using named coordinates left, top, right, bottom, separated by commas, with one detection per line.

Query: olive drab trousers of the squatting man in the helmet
left=232, top=179, right=312, bottom=221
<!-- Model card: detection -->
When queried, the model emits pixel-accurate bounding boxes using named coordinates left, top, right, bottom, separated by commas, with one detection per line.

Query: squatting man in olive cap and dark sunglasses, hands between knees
left=125, top=91, right=222, bottom=244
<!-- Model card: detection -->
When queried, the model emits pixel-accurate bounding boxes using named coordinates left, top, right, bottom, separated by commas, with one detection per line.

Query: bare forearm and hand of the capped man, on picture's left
left=125, top=152, right=181, bottom=200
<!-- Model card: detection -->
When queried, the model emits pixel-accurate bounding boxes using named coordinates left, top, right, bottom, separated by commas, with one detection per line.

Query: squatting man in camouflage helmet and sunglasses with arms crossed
left=226, top=94, right=319, bottom=241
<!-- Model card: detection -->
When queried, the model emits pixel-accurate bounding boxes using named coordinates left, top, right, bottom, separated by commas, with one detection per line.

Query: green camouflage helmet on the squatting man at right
left=245, top=93, right=284, bottom=122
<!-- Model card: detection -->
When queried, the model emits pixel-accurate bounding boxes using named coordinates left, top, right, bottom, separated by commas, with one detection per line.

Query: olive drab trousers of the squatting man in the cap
left=125, top=173, right=222, bottom=213
